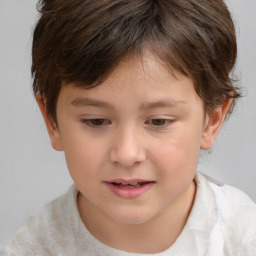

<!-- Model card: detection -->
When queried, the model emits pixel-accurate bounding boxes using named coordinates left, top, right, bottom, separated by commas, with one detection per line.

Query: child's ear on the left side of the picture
left=36, top=94, right=63, bottom=151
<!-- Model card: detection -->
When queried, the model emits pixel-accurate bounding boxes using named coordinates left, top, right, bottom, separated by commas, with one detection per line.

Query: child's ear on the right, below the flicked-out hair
left=200, top=99, right=232, bottom=150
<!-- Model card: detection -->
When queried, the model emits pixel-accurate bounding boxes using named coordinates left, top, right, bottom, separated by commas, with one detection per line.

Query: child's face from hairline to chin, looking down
left=38, top=52, right=226, bottom=224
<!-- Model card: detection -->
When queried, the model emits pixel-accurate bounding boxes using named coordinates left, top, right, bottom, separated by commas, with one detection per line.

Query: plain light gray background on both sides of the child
left=0, top=0, right=256, bottom=244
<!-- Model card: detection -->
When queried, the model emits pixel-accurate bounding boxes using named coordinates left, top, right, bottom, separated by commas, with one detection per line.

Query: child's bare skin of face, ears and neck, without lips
left=37, top=53, right=231, bottom=253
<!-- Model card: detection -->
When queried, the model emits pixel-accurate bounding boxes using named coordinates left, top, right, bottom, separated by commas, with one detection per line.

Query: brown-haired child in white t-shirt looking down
left=10, top=0, right=256, bottom=256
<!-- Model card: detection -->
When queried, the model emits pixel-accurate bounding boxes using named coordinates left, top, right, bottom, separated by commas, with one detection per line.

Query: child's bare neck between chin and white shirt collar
left=78, top=181, right=196, bottom=254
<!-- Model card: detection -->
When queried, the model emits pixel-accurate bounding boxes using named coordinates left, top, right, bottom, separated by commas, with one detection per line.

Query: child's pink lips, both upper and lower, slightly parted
left=104, top=179, right=155, bottom=199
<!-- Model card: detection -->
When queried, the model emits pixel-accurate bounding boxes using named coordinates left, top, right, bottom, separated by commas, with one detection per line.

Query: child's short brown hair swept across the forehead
left=32, top=0, right=240, bottom=121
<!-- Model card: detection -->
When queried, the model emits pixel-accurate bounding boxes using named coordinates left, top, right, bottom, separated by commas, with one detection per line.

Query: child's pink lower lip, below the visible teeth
left=106, top=182, right=154, bottom=199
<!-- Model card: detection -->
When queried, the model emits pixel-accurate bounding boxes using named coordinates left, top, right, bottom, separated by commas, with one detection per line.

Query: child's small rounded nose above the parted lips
left=110, top=126, right=146, bottom=168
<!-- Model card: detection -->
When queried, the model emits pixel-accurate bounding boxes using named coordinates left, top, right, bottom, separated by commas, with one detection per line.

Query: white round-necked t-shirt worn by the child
left=8, top=173, right=256, bottom=256
